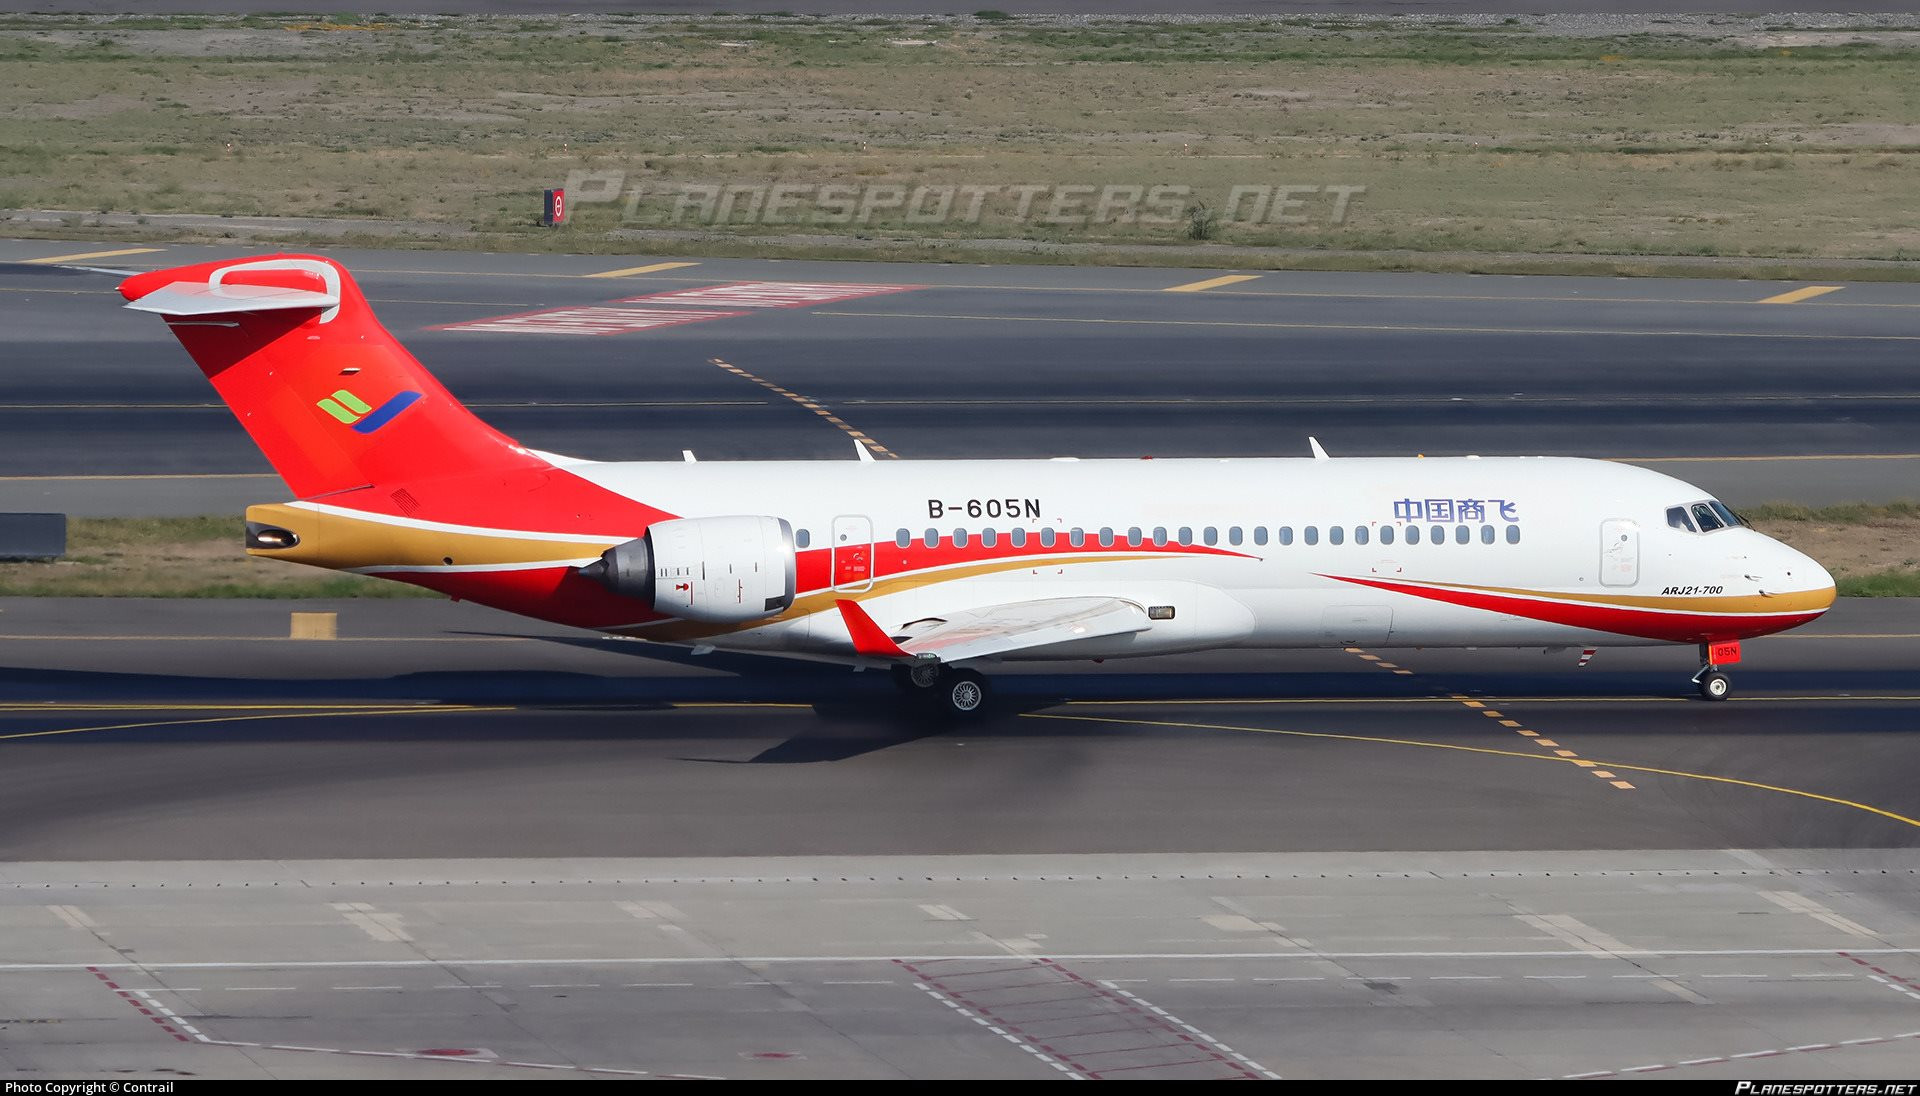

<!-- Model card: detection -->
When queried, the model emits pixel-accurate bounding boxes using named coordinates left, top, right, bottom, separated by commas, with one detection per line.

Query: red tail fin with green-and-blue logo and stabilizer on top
left=119, top=255, right=547, bottom=499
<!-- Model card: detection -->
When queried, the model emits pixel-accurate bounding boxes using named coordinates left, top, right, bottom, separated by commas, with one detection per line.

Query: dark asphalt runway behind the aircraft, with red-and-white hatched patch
left=0, top=242, right=1920, bottom=514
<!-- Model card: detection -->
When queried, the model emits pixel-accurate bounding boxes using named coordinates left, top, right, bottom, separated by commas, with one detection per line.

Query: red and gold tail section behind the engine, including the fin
left=119, top=255, right=672, bottom=626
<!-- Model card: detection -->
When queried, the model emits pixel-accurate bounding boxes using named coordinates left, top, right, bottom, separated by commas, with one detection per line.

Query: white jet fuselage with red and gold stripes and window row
left=275, top=457, right=1834, bottom=660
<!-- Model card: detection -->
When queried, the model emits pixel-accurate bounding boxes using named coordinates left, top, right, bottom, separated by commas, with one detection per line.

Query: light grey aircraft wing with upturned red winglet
left=837, top=597, right=1150, bottom=662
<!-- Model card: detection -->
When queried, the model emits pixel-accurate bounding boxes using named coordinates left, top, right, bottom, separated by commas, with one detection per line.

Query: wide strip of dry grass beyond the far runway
left=0, top=17, right=1920, bottom=259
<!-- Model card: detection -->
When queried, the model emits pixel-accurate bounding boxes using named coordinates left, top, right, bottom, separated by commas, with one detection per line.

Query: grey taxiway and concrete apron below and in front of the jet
left=0, top=599, right=1920, bottom=1079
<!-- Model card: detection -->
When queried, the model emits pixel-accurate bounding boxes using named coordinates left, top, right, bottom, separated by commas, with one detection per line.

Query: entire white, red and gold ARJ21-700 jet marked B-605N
left=121, top=255, right=1834, bottom=712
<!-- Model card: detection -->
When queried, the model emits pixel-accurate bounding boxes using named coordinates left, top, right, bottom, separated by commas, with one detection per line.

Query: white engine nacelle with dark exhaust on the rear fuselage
left=580, top=516, right=797, bottom=624
